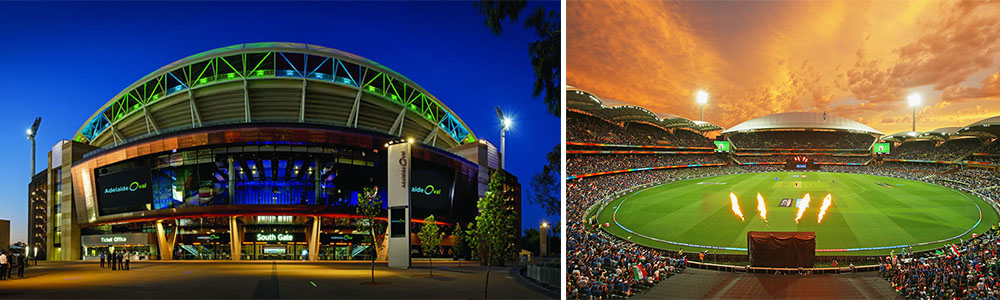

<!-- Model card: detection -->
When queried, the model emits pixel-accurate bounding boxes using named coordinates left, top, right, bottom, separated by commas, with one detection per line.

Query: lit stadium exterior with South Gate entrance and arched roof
left=44, top=43, right=520, bottom=260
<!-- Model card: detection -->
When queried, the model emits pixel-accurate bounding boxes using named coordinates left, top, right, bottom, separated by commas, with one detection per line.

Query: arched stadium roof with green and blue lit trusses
left=74, top=42, right=476, bottom=147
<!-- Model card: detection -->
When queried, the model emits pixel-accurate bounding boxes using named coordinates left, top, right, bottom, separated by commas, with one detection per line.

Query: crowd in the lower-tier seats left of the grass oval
left=566, top=166, right=745, bottom=299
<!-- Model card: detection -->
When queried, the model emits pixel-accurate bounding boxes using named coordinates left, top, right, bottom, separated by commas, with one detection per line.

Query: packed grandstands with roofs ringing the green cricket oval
left=566, top=87, right=1000, bottom=299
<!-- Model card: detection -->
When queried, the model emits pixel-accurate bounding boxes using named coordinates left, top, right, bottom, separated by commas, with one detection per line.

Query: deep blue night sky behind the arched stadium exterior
left=0, top=1, right=560, bottom=242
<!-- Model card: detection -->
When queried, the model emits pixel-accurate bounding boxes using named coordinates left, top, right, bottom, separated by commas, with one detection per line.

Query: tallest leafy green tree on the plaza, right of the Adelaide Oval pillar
left=470, top=171, right=518, bottom=298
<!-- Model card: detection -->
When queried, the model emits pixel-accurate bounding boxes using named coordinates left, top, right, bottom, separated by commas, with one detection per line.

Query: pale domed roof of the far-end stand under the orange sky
left=722, top=112, right=882, bottom=135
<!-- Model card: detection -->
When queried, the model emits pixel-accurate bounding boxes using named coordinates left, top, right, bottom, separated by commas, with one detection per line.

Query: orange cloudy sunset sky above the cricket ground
left=566, top=1, right=1000, bottom=134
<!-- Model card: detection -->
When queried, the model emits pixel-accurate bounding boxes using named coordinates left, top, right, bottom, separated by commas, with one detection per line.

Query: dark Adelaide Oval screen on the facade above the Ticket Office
left=97, top=167, right=153, bottom=216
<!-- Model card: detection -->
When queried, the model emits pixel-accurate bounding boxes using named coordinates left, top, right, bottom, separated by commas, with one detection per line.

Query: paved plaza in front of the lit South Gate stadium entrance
left=0, top=260, right=558, bottom=299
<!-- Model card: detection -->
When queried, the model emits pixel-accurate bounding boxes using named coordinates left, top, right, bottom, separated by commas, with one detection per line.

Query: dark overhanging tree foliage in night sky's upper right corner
left=475, top=0, right=562, bottom=116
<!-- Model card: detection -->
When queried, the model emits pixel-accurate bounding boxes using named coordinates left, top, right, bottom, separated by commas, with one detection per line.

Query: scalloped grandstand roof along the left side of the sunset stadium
left=566, top=86, right=723, bottom=132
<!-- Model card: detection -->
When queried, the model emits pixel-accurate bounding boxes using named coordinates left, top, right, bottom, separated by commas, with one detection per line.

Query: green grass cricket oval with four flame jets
left=598, top=172, right=998, bottom=255
